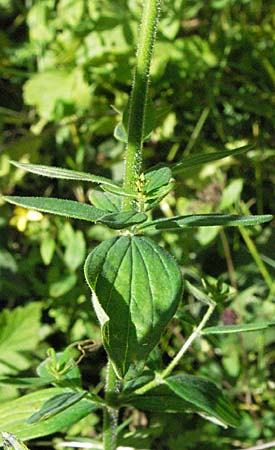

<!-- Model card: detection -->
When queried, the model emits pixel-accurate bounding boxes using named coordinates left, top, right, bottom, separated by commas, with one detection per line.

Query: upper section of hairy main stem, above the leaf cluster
left=124, top=0, right=160, bottom=210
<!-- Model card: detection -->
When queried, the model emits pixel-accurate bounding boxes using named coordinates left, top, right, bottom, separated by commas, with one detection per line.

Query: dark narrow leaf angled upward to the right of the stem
left=172, top=144, right=255, bottom=175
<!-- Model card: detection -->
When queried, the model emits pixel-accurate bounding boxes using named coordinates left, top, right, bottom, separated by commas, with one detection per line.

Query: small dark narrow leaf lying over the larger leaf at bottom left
left=27, top=391, right=87, bottom=423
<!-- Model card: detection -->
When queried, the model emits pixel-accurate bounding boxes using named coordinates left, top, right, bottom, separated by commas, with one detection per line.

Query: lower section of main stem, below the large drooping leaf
left=103, top=362, right=119, bottom=450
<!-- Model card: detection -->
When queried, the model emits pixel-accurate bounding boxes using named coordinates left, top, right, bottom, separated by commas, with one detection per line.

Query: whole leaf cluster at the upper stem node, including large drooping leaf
left=6, top=153, right=272, bottom=379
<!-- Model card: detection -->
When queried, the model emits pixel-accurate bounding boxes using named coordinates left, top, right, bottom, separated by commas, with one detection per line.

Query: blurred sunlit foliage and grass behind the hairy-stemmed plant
left=0, top=0, right=275, bottom=450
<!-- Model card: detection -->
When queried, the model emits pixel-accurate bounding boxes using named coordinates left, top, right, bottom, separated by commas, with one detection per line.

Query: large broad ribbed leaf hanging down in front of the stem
left=84, top=236, right=182, bottom=378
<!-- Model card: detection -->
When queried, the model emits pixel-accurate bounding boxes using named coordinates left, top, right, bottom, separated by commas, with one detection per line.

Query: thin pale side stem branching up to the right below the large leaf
left=135, top=302, right=216, bottom=394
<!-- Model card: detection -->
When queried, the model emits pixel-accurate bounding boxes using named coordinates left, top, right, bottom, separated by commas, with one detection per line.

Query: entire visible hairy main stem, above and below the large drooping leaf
left=103, top=0, right=160, bottom=450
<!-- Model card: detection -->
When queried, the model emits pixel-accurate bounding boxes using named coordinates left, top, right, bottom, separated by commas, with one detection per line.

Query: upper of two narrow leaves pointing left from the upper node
left=10, top=161, right=123, bottom=191
